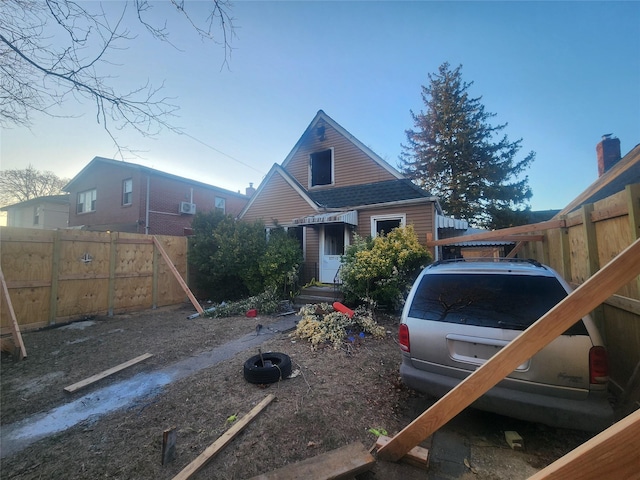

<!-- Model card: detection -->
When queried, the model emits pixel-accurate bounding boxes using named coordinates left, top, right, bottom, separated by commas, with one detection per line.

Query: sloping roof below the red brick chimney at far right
left=556, top=144, right=640, bottom=217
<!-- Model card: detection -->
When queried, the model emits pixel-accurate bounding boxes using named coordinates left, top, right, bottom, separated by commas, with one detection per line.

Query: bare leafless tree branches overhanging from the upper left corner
left=0, top=0, right=233, bottom=153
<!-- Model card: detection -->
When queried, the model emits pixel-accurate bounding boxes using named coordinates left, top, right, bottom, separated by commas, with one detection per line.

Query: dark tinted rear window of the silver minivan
left=409, top=273, right=588, bottom=335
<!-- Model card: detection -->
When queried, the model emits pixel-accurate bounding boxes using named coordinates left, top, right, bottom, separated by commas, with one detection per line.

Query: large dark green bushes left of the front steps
left=189, top=211, right=302, bottom=302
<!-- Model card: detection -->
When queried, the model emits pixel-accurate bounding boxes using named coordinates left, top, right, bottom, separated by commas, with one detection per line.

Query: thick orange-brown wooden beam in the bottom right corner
left=529, top=410, right=640, bottom=480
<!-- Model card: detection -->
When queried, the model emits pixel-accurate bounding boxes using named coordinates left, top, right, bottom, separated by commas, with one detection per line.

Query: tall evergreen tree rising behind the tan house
left=400, top=62, right=535, bottom=228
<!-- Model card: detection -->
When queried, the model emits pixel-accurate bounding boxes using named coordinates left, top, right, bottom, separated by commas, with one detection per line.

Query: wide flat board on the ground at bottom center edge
left=245, top=442, right=376, bottom=480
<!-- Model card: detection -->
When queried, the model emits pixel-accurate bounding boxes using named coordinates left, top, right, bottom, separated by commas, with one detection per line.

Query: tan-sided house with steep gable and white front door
left=238, top=110, right=467, bottom=283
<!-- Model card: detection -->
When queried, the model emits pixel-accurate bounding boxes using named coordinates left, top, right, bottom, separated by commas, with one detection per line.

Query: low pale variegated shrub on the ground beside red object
left=296, top=303, right=386, bottom=350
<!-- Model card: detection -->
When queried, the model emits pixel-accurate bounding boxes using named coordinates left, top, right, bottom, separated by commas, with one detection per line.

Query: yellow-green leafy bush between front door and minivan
left=340, top=225, right=431, bottom=310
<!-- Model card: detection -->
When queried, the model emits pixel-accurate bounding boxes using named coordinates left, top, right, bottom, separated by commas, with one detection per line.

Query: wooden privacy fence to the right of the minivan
left=521, top=184, right=640, bottom=392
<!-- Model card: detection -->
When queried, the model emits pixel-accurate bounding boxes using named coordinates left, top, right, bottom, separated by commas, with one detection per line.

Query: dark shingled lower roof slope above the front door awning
left=308, top=179, right=431, bottom=208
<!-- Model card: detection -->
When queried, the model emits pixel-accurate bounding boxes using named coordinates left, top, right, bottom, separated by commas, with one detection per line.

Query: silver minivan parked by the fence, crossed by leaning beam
left=399, top=259, right=613, bottom=431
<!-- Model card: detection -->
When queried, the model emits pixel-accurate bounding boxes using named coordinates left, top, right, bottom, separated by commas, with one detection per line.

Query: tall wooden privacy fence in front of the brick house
left=0, top=227, right=187, bottom=334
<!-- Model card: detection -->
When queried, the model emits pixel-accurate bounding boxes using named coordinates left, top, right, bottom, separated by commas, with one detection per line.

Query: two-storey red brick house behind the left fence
left=64, top=157, right=249, bottom=235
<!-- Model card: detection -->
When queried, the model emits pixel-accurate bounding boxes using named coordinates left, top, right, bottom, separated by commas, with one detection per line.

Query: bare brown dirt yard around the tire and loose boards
left=1, top=305, right=589, bottom=480
